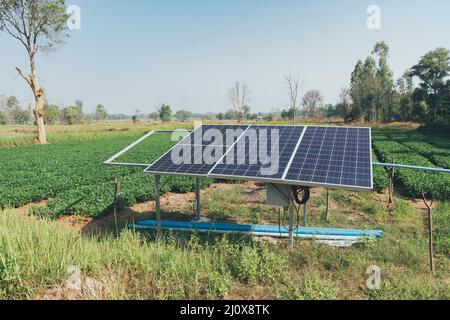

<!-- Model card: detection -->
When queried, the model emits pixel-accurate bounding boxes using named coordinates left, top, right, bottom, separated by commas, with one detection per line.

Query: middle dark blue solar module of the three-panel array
left=210, top=126, right=304, bottom=180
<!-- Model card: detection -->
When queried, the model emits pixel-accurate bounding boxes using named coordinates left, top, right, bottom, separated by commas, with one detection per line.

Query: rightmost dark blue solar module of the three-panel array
left=285, top=127, right=373, bottom=189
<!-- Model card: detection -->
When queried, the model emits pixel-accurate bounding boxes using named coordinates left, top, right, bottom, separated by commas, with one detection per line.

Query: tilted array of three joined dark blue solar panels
left=146, top=125, right=373, bottom=190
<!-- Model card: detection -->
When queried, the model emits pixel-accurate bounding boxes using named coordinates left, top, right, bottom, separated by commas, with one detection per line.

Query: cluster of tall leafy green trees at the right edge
left=346, top=42, right=450, bottom=123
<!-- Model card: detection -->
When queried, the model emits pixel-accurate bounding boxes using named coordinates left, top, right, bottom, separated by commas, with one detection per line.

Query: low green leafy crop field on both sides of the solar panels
left=0, top=122, right=450, bottom=217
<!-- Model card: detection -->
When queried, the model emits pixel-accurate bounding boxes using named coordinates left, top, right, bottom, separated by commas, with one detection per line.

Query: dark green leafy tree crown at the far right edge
left=411, top=48, right=450, bottom=119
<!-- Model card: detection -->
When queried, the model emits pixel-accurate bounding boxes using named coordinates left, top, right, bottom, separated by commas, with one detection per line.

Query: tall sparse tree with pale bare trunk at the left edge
left=0, top=0, right=68, bottom=144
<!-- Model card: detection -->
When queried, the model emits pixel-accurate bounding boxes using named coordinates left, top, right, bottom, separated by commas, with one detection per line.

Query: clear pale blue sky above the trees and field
left=0, top=0, right=450, bottom=113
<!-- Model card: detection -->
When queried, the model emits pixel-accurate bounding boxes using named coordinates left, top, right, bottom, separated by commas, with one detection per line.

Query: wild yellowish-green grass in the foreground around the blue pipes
left=0, top=185, right=450, bottom=299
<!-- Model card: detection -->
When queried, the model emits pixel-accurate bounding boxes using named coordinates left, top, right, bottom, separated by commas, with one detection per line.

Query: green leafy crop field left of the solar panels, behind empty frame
left=0, top=126, right=208, bottom=217
